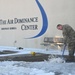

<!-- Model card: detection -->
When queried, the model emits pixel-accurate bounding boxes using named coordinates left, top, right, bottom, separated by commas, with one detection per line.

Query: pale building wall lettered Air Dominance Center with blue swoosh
left=0, top=0, right=75, bottom=48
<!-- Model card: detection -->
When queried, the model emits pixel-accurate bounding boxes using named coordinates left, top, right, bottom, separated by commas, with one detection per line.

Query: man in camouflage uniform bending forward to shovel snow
left=57, top=24, right=75, bottom=61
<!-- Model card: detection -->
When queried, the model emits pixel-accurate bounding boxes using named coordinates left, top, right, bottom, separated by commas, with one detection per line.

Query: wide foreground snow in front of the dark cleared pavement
left=0, top=61, right=75, bottom=75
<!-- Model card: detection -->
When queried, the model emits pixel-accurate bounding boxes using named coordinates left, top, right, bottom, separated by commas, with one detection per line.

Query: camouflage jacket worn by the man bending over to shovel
left=62, top=24, right=75, bottom=44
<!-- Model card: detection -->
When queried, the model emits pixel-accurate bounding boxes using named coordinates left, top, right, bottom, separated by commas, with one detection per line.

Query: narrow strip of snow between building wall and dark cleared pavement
left=0, top=46, right=68, bottom=56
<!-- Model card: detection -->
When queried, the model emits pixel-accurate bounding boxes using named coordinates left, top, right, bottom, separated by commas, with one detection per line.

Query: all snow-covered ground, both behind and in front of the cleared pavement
left=0, top=46, right=75, bottom=75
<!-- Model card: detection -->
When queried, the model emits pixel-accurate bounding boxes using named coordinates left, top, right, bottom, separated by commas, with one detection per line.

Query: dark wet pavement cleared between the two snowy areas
left=0, top=51, right=75, bottom=62
